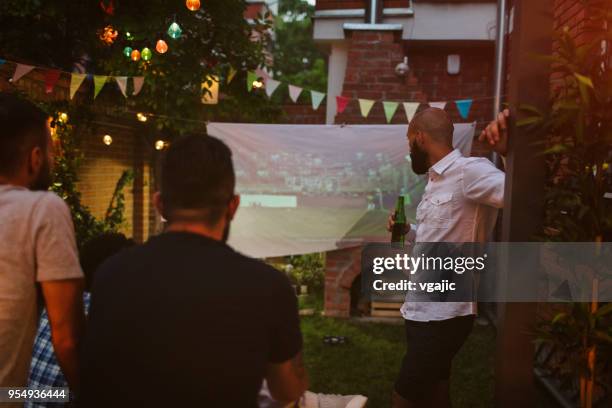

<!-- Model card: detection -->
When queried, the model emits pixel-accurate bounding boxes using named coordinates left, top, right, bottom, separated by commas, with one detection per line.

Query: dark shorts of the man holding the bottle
left=395, top=316, right=474, bottom=401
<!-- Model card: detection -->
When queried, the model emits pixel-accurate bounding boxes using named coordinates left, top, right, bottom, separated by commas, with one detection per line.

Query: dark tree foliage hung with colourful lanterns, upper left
left=0, top=0, right=279, bottom=134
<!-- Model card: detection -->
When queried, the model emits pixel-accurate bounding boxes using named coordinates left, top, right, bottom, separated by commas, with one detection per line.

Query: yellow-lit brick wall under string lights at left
left=0, top=63, right=155, bottom=241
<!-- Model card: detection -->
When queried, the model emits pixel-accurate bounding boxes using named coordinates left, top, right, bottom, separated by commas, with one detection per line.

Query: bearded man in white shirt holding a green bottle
left=389, top=108, right=509, bottom=408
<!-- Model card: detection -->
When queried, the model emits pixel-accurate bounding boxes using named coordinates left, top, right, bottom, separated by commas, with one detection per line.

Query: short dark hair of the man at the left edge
left=0, top=92, right=49, bottom=176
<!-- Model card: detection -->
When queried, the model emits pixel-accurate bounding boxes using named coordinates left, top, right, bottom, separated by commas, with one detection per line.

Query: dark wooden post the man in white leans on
left=495, top=0, right=553, bottom=408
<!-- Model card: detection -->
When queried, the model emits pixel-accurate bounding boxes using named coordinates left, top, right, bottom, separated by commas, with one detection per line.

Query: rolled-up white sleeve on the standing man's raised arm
left=462, top=158, right=506, bottom=208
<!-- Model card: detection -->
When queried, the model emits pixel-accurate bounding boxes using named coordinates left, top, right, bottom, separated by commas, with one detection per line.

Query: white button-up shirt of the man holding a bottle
left=401, top=150, right=505, bottom=321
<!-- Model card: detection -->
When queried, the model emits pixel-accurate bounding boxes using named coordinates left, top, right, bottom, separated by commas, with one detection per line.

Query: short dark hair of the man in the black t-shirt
left=161, top=135, right=236, bottom=226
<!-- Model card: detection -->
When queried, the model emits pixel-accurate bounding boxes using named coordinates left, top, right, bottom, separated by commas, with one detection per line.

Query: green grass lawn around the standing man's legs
left=302, top=296, right=495, bottom=408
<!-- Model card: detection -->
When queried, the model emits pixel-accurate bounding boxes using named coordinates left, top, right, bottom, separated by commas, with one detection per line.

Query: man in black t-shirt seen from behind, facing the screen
left=80, top=136, right=307, bottom=408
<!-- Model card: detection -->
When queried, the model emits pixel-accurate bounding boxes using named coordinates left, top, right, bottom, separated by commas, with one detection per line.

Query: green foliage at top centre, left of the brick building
left=273, top=0, right=327, bottom=92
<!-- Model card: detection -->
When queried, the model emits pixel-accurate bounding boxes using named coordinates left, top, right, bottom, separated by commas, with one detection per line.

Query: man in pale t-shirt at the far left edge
left=0, top=93, right=84, bottom=390
